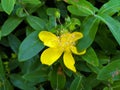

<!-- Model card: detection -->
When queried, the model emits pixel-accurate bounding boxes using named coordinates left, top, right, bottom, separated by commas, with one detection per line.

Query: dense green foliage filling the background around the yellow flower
left=0, top=0, right=120, bottom=90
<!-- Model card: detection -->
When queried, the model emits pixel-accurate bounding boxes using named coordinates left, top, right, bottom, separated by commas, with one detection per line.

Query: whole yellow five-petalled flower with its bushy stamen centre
left=39, top=31, right=86, bottom=72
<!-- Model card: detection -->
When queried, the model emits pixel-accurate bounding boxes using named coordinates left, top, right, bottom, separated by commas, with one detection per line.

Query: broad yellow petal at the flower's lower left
left=41, top=48, right=63, bottom=65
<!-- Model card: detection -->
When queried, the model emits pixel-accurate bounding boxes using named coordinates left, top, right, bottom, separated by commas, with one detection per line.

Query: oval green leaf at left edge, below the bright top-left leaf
left=1, top=17, right=23, bottom=36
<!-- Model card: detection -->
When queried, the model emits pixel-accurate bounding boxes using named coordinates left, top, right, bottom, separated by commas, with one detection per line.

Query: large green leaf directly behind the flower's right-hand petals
left=77, top=17, right=99, bottom=51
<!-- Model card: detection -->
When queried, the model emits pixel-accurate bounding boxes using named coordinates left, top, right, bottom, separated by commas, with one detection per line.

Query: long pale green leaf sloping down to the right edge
left=96, top=14, right=120, bottom=45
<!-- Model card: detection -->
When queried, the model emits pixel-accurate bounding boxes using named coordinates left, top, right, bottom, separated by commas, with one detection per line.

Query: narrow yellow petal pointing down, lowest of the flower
left=63, top=51, right=76, bottom=72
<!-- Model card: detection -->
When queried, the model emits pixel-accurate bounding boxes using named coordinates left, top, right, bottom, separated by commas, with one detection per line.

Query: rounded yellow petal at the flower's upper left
left=39, top=31, right=59, bottom=47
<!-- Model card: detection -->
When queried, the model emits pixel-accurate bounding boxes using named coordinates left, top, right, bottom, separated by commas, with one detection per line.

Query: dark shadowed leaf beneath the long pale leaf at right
left=95, top=23, right=118, bottom=54
